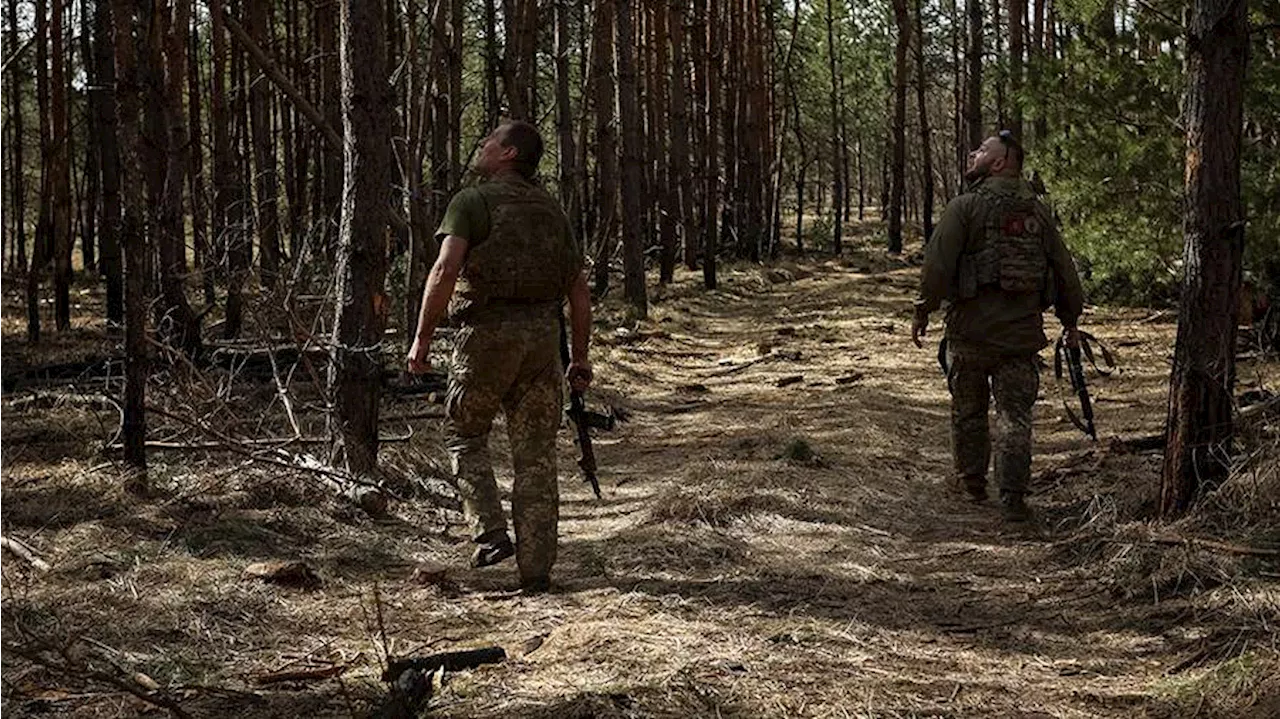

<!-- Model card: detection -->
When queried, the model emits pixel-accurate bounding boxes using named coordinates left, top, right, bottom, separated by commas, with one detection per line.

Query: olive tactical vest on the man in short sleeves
left=453, top=178, right=581, bottom=313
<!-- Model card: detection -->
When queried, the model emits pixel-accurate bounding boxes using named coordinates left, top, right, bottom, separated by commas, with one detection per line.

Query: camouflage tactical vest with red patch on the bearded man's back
left=957, top=180, right=1052, bottom=306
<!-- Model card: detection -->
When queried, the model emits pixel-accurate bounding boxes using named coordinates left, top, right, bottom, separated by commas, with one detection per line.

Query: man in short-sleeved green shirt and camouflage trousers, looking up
left=408, top=122, right=591, bottom=591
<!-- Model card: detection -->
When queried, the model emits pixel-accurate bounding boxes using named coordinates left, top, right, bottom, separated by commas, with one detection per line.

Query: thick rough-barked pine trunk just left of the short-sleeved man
left=329, top=0, right=396, bottom=475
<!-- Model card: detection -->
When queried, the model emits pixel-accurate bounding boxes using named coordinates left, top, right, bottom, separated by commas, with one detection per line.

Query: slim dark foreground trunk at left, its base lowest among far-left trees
left=111, top=0, right=147, bottom=470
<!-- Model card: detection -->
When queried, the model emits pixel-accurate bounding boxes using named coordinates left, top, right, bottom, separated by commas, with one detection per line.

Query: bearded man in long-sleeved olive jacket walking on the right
left=911, top=130, right=1084, bottom=522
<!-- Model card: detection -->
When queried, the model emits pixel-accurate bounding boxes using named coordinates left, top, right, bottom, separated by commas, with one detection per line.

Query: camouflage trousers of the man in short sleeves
left=444, top=306, right=564, bottom=580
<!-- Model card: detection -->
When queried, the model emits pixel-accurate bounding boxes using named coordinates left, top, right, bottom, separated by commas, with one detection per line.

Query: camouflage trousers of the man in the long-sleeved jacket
left=947, top=340, right=1039, bottom=494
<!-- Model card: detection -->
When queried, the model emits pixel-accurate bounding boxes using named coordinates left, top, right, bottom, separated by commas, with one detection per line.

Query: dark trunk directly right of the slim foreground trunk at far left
left=156, top=0, right=201, bottom=357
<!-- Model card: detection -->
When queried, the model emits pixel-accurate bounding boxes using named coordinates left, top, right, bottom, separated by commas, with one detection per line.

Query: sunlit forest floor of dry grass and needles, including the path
left=0, top=225, right=1280, bottom=718
